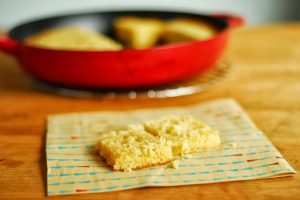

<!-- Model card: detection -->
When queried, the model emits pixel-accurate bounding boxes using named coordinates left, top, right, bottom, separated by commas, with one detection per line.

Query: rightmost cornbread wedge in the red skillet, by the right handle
left=162, top=18, right=217, bottom=43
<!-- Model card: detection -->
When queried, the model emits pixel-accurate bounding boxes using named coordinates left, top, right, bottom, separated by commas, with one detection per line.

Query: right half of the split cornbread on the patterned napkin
left=144, top=116, right=221, bottom=155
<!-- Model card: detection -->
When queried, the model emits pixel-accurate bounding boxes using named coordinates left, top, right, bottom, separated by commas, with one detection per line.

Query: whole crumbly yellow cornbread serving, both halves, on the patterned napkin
left=99, top=116, right=220, bottom=171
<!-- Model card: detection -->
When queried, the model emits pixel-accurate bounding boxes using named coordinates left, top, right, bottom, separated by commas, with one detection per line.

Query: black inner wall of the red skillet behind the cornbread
left=9, top=11, right=228, bottom=42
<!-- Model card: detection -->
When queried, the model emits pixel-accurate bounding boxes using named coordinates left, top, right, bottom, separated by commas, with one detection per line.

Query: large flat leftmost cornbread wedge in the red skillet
left=25, top=27, right=122, bottom=51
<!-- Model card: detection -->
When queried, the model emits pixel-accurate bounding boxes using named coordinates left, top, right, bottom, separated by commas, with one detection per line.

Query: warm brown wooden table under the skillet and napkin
left=0, top=24, right=300, bottom=199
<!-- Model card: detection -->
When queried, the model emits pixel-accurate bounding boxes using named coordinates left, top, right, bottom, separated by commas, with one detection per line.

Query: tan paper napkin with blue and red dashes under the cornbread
left=46, top=99, right=295, bottom=195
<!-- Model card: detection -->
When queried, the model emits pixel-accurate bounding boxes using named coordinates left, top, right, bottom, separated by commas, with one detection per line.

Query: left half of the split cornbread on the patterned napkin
left=99, top=125, right=173, bottom=171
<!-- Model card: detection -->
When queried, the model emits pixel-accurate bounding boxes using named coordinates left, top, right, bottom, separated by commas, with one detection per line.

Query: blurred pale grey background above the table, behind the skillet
left=0, top=0, right=300, bottom=29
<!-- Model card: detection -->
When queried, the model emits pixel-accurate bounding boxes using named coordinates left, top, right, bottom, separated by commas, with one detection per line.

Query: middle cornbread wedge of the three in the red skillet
left=114, top=16, right=164, bottom=49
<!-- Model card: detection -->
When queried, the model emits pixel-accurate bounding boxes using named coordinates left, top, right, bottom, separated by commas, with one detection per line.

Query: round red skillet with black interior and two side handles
left=0, top=11, right=243, bottom=88
